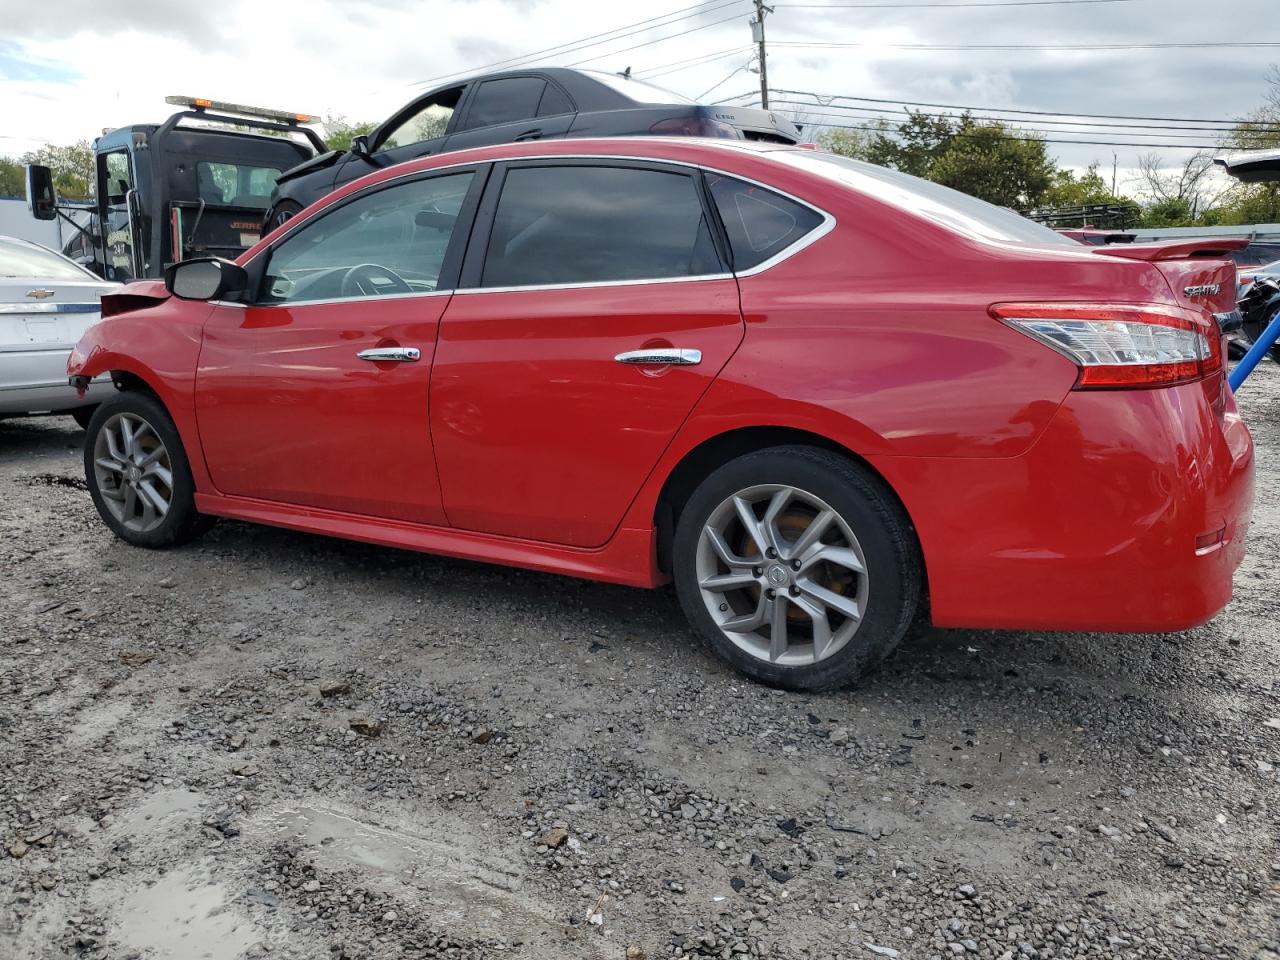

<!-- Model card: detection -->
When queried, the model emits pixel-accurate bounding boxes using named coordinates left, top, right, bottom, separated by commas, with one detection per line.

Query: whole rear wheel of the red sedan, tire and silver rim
left=672, top=447, right=922, bottom=690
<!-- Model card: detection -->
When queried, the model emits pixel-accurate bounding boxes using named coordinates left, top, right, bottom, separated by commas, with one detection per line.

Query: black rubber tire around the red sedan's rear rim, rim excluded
left=672, top=445, right=923, bottom=690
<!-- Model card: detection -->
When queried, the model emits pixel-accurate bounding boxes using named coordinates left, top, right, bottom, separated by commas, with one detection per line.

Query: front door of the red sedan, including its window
left=196, top=168, right=485, bottom=524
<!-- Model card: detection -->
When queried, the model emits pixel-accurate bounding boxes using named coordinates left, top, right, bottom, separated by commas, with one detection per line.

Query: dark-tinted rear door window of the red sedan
left=480, top=165, right=722, bottom=287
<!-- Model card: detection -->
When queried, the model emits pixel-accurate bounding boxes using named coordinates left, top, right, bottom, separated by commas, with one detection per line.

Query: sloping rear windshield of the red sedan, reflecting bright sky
left=771, top=150, right=1079, bottom=247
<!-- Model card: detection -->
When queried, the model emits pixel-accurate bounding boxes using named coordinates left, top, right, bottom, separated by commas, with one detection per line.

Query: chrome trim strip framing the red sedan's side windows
left=244, top=147, right=836, bottom=293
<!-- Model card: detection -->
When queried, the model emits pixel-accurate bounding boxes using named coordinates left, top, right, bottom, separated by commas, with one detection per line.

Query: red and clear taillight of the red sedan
left=991, top=303, right=1222, bottom=390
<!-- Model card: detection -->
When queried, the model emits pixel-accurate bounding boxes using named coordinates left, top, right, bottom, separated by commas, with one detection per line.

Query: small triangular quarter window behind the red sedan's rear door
left=707, top=173, right=822, bottom=270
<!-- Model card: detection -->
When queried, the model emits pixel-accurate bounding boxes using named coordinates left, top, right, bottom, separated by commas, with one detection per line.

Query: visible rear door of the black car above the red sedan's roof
left=448, top=76, right=575, bottom=150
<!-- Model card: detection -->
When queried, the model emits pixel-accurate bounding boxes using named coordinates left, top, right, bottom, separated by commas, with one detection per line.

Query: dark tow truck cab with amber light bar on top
left=27, top=96, right=325, bottom=282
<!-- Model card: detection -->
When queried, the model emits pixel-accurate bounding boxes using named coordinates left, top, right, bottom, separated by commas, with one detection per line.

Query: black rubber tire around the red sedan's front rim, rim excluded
left=84, top=390, right=214, bottom=549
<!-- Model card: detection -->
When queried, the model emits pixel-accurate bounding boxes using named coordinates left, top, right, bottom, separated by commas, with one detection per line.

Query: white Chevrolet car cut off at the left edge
left=0, top=237, right=120, bottom=426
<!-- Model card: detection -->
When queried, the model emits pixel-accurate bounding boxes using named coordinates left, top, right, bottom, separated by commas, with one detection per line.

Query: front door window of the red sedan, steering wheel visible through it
left=261, top=172, right=474, bottom=303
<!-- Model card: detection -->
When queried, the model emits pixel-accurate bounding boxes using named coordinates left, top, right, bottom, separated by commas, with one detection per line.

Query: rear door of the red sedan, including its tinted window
left=431, top=160, right=744, bottom=547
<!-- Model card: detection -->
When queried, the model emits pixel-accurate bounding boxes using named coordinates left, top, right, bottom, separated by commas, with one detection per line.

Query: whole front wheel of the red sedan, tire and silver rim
left=84, top=390, right=212, bottom=549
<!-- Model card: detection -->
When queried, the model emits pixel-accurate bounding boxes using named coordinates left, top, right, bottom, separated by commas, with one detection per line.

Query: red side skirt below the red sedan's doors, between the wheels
left=196, top=493, right=669, bottom=588
